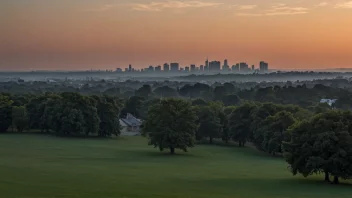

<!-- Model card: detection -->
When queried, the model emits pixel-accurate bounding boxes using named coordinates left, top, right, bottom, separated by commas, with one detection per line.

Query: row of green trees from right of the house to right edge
left=142, top=99, right=352, bottom=184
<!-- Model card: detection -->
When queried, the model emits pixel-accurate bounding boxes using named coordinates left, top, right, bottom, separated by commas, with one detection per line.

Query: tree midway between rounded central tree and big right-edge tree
left=228, top=103, right=257, bottom=147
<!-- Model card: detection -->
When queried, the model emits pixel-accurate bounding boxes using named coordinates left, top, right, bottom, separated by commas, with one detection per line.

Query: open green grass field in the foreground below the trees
left=0, top=134, right=352, bottom=198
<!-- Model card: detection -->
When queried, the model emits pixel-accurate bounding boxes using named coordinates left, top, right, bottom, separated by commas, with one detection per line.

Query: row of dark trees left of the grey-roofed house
left=0, top=92, right=121, bottom=137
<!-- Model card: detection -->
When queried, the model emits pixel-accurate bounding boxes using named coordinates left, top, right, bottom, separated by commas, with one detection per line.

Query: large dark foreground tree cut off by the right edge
left=283, top=111, right=352, bottom=184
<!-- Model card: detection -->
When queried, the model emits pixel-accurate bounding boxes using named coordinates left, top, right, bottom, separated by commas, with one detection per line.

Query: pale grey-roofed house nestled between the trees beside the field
left=119, top=113, right=142, bottom=136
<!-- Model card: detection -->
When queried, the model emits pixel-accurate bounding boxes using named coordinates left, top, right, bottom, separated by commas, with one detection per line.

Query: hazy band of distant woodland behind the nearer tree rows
left=0, top=79, right=352, bottom=109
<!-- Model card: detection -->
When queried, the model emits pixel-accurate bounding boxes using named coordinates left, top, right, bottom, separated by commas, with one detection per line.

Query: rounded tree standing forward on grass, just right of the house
left=142, top=99, right=198, bottom=154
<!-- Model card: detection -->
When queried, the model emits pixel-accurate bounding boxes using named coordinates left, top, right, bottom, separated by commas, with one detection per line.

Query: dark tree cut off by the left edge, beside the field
left=0, top=94, right=13, bottom=133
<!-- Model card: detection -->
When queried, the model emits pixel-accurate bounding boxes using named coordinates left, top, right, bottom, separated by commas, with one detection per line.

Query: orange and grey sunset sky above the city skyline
left=0, top=0, right=352, bottom=70
